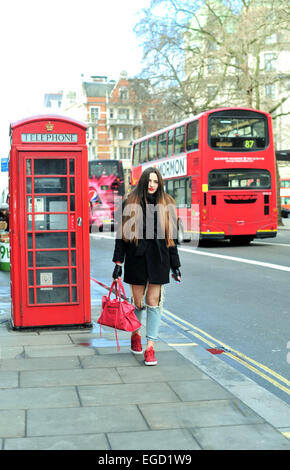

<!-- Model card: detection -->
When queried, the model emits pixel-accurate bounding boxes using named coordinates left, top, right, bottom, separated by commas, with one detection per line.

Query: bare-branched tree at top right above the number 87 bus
left=135, top=0, right=290, bottom=118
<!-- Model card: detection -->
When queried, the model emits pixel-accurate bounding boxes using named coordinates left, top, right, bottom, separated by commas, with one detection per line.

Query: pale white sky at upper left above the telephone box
left=0, top=0, right=150, bottom=158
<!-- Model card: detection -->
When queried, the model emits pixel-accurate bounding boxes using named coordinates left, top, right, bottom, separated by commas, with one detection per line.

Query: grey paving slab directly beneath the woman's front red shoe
left=117, top=364, right=209, bottom=383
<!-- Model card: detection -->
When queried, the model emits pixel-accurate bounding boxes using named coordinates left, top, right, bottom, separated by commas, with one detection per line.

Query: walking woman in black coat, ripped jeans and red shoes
left=113, top=167, right=181, bottom=366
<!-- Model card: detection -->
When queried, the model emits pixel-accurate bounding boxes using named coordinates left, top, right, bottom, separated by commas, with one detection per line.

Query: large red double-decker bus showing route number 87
left=131, top=108, right=277, bottom=244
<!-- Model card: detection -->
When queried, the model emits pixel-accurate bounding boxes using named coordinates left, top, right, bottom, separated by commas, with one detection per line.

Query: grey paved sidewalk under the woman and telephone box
left=0, top=271, right=290, bottom=450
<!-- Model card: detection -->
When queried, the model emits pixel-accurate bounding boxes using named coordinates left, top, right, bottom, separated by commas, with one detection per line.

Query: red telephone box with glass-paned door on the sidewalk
left=9, top=115, right=91, bottom=328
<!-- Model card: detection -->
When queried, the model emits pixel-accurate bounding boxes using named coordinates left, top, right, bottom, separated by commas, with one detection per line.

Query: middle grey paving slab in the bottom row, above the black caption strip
left=108, top=429, right=200, bottom=451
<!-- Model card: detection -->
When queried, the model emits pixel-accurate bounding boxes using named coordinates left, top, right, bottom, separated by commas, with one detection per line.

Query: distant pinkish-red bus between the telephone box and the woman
left=89, top=160, right=125, bottom=231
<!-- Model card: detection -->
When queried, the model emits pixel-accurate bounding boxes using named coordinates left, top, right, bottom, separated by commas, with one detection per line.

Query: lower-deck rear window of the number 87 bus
left=208, top=168, right=271, bottom=190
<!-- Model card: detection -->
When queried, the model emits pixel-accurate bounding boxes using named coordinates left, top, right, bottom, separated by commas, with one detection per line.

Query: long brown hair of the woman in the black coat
left=122, top=167, right=177, bottom=247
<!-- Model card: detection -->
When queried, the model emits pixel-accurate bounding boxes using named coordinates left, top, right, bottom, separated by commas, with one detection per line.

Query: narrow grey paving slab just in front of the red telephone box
left=24, top=345, right=95, bottom=357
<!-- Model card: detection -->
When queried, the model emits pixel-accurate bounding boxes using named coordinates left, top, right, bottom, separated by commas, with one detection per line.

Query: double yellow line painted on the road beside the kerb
left=163, top=310, right=290, bottom=394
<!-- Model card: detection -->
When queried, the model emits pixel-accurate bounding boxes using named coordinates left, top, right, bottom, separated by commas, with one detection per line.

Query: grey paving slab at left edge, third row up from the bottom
left=0, top=387, right=80, bottom=410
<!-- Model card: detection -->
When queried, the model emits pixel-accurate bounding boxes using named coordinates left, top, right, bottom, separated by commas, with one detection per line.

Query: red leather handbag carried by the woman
left=97, top=279, right=141, bottom=351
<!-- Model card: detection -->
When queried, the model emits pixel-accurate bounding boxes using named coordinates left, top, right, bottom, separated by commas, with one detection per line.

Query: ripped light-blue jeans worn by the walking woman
left=131, top=284, right=164, bottom=341
